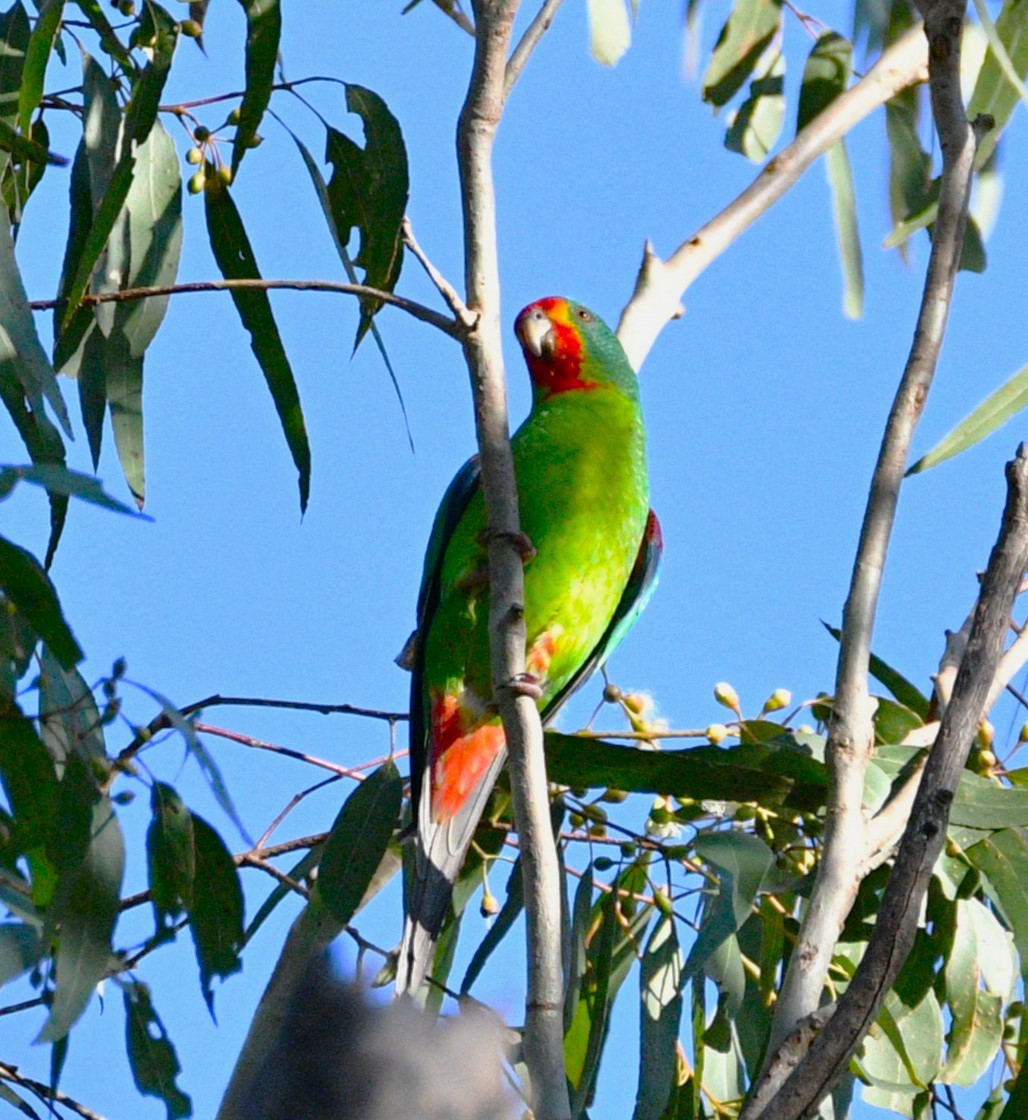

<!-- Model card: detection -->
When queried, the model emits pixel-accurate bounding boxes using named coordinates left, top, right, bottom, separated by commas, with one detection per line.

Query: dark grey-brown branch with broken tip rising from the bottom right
left=742, top=443, right=1028, bottom=1120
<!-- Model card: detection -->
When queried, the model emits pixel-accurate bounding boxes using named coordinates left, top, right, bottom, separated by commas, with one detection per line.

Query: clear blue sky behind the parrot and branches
left=3, top=0, right=1028, bottom=1120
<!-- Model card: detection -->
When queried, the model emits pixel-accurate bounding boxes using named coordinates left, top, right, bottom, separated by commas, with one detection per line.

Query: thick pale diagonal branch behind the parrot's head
left=617, top=27, right=927, bottom=370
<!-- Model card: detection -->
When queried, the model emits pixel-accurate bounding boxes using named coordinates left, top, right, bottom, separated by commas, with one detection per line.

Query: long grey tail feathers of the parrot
left=396, top=748, right=507, bottom=997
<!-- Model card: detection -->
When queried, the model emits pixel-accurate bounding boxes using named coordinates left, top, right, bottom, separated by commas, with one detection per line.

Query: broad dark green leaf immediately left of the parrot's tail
left=317, top=762, right=403, bottom=925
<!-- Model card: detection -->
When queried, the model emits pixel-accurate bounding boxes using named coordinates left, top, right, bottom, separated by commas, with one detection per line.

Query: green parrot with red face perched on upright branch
left=396, top=297, right=663, bottom=998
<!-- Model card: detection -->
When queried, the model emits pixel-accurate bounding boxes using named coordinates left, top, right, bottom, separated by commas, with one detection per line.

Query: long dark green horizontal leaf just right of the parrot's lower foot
left=545, top=730, right=825, bottom=808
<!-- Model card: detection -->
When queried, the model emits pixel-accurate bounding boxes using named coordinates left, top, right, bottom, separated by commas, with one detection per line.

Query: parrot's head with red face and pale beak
left=514, top=296, right=637, bottom=399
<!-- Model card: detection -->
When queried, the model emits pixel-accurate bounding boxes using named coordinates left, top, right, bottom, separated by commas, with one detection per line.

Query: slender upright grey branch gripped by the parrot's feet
left=457, top=0, right=570, bottom=1120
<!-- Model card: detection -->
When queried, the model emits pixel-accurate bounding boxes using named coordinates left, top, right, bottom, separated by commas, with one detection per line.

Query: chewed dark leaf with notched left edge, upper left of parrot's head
left=325, top=83, right=410, bottom=349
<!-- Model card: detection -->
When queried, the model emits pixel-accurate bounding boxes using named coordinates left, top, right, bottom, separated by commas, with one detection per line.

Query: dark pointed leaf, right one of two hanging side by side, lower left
left=189, top=813, right=243, bottom=1017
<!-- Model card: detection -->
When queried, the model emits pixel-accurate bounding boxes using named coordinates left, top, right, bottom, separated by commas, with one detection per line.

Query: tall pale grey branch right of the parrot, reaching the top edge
left=768, top=0, right=991, bottom=1093
